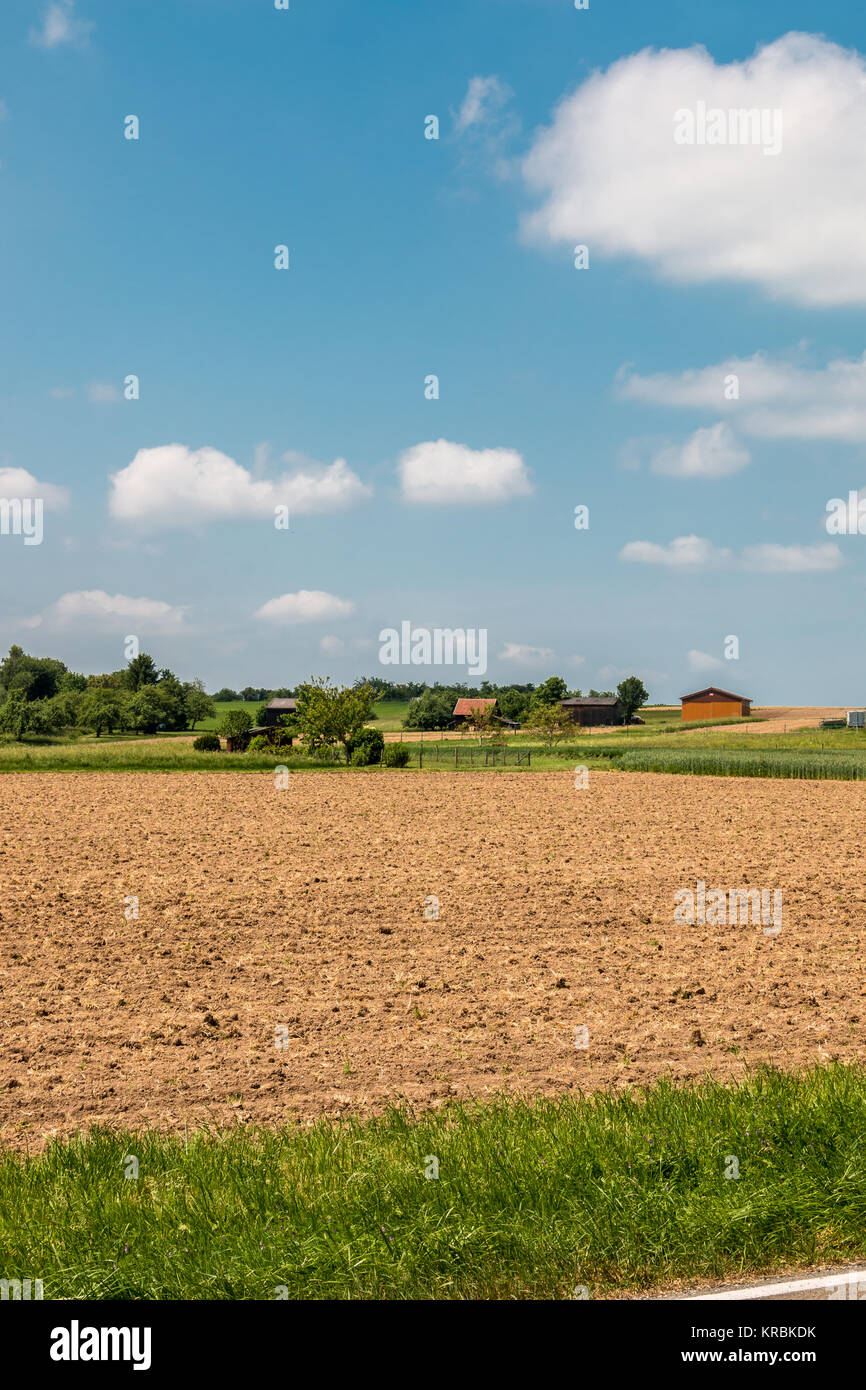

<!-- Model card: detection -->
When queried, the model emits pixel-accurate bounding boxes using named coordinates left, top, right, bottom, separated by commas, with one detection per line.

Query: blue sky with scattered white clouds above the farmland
left=0, top=0, right=866, bottom=703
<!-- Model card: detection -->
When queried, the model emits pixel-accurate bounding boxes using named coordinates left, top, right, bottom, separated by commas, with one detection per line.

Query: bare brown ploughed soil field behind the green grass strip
left=0, top=770, right=866, bottom=1148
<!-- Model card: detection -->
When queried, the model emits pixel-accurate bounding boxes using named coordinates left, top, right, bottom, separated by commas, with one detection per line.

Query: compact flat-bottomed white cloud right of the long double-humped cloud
left=398, top=439, right=532, bottom=505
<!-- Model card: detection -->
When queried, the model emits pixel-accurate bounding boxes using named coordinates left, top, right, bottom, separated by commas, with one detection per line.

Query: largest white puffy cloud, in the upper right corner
left=523, top=33, right=866, bottom=304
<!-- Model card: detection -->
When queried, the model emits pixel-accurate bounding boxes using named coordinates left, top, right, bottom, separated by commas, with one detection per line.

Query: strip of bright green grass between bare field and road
left=0, top=1063, right=866, bottom=1300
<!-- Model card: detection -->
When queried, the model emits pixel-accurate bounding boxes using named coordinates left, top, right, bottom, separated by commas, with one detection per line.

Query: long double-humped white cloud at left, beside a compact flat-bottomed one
left=110, top=443, right=373, bottom=525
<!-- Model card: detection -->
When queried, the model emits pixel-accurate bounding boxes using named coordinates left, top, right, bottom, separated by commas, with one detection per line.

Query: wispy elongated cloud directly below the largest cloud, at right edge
left=619, top=353, right=866, bottom=443
